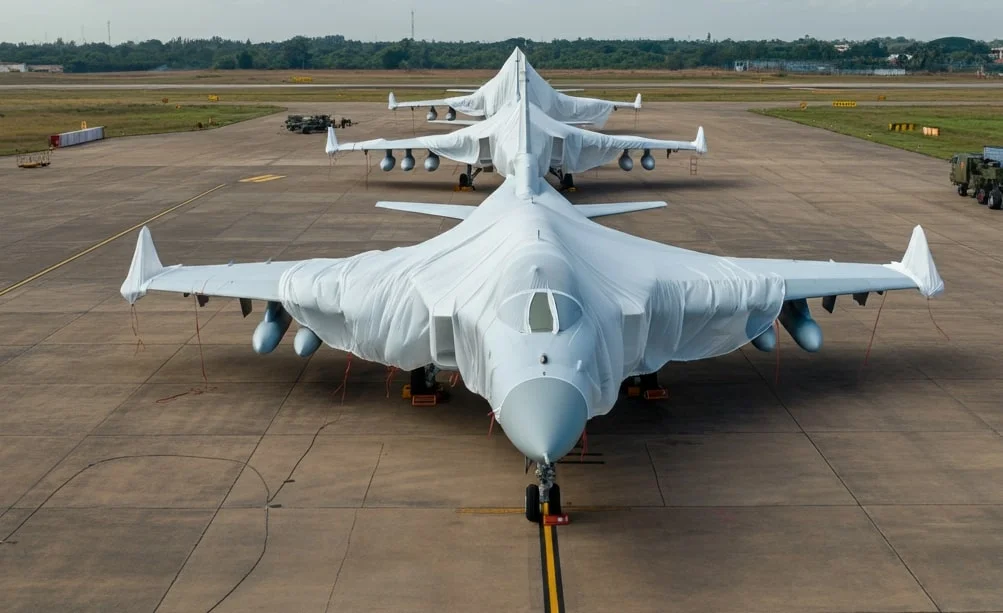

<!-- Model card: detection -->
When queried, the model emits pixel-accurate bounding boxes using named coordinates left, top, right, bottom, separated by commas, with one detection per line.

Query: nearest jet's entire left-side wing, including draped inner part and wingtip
left=120, top=227, right=431, bottom=369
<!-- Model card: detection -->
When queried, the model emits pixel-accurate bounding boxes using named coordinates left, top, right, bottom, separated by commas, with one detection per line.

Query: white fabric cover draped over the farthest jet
left=391, top=48, right=617, bottom=127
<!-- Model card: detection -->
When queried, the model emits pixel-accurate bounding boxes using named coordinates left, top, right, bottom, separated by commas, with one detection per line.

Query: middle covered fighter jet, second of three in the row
left=325, top=92, right=707, bottom=189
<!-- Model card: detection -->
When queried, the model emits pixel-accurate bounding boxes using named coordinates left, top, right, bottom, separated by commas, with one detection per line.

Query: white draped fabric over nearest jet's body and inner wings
left=279, top=180, right=783, bottom=415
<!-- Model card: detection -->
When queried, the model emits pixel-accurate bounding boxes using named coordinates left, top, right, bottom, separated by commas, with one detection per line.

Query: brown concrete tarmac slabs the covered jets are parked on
left=0, top=103, right=1003, bottom=613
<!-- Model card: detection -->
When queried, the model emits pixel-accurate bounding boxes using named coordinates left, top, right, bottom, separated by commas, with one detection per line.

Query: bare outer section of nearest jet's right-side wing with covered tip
left=727, top=226, right=944, bottom=308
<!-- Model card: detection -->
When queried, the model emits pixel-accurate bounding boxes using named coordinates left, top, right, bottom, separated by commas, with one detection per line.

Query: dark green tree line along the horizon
left=0, top=34, right=1003, bottom=72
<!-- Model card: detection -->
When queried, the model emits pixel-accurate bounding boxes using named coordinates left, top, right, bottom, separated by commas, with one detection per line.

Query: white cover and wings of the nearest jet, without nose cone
left=121, top=177, right=943, bottom=420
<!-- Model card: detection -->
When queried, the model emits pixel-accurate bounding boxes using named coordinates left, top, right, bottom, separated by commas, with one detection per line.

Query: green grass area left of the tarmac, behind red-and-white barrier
left=0, top=103, right=282, bottom=156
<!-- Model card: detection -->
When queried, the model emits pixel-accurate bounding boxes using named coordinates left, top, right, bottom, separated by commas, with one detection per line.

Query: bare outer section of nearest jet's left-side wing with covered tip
left=120, top=226, right=296, bottom=304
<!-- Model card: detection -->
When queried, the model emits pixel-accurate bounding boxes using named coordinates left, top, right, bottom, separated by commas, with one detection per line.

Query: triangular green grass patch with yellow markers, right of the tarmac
left=754, top=106, right=1003, bottom=159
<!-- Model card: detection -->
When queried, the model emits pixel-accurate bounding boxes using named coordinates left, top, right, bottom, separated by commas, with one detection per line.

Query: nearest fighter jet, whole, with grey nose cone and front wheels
left=121, top=64, right=944, bottom=522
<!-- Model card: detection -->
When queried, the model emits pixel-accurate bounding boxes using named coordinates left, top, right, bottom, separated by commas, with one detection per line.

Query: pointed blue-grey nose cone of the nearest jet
left=499, top=377, right=589, bottom=462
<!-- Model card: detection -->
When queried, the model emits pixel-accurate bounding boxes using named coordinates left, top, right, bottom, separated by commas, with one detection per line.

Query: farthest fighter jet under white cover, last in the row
left=389, top=47, right=641, bottom=127
